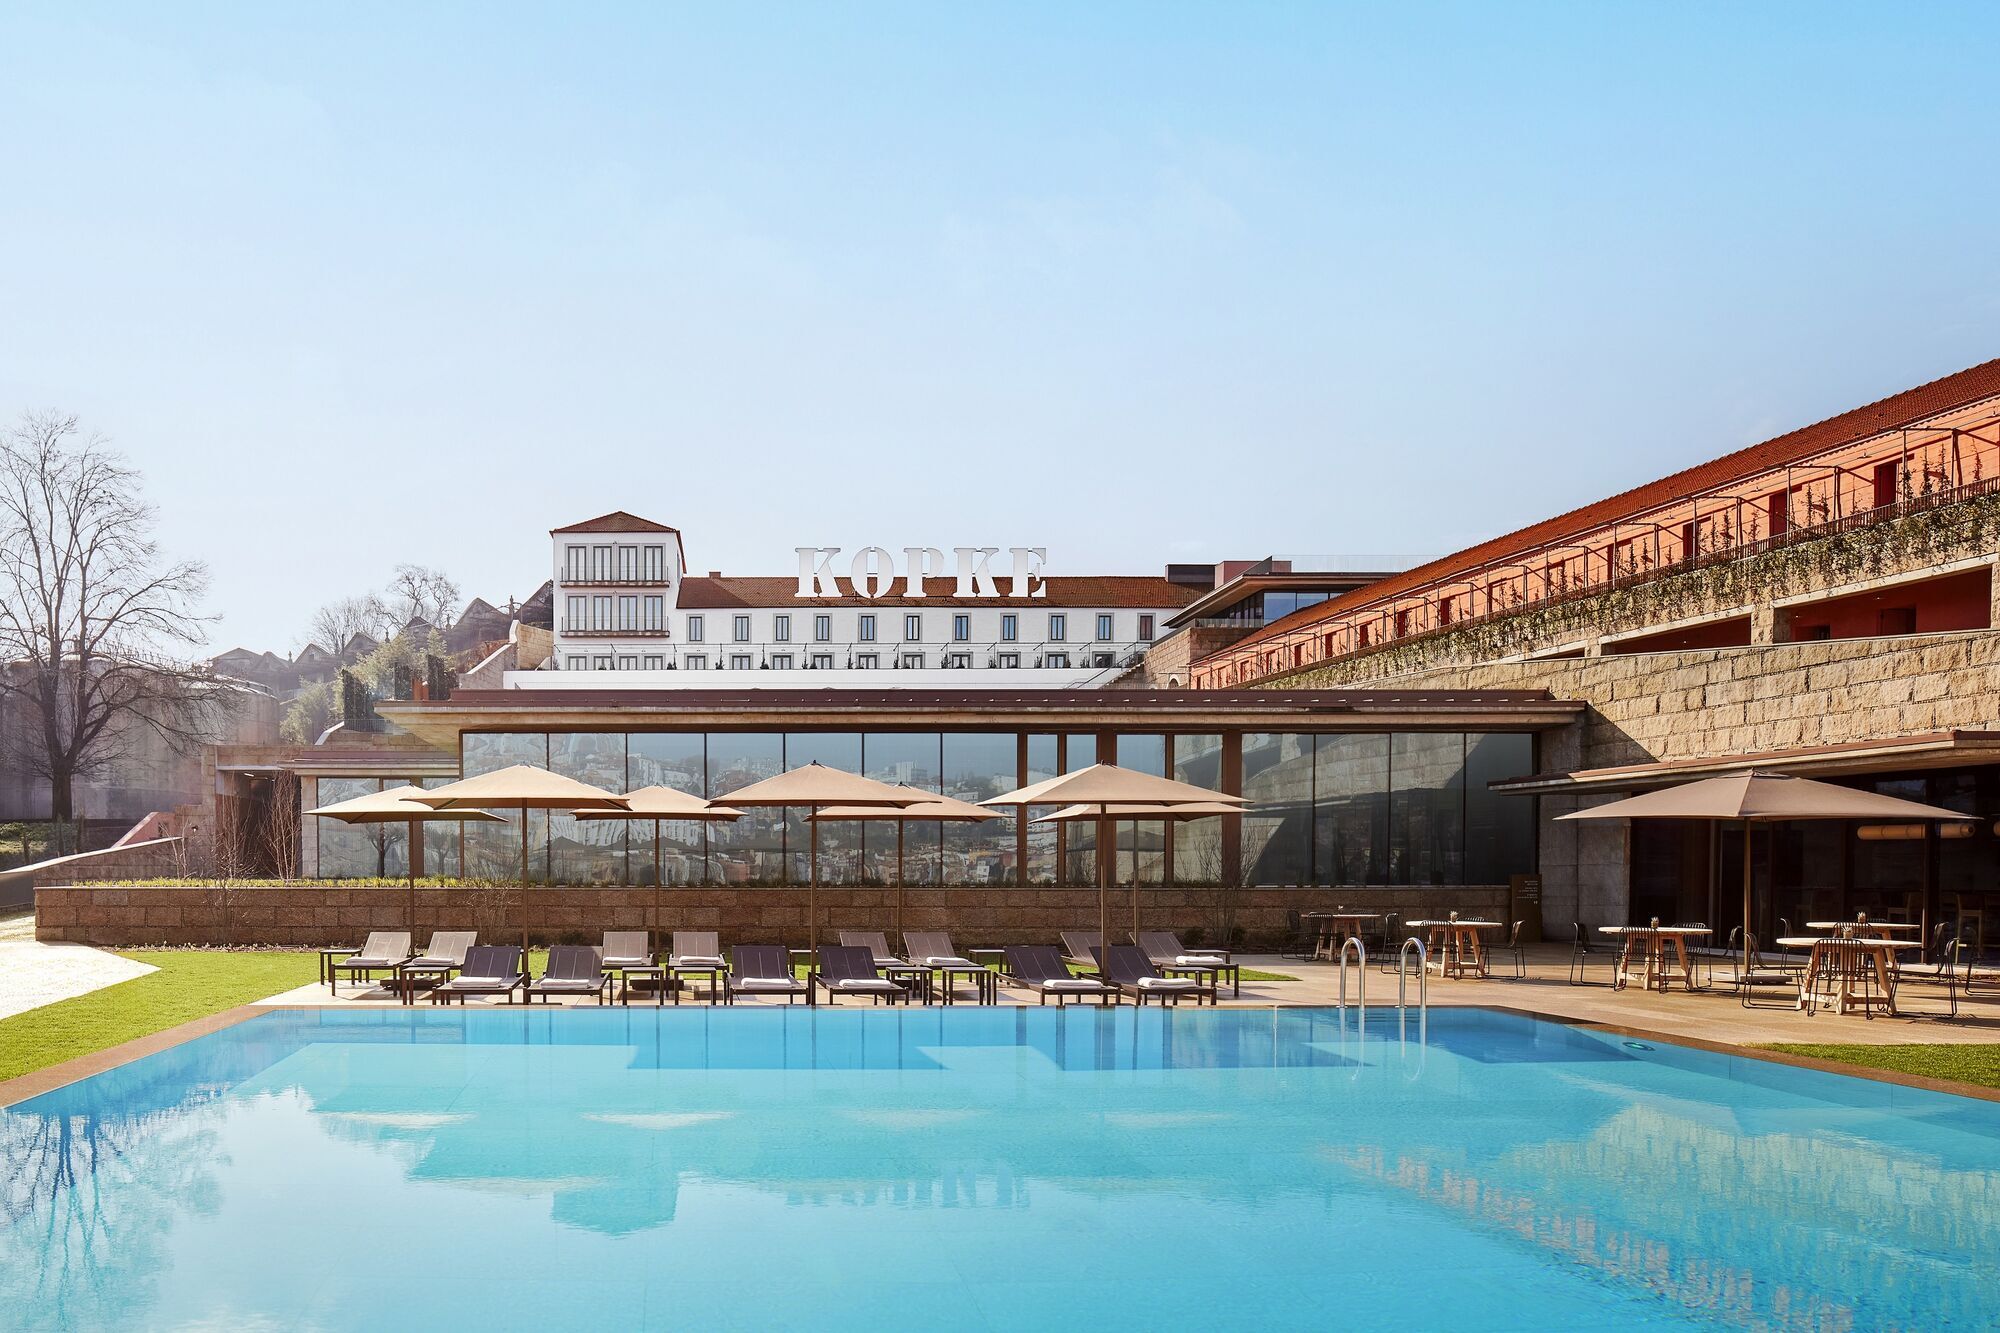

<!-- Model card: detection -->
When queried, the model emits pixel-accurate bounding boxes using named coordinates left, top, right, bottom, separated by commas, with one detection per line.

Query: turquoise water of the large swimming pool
left=0, top=1007, right=2000, bottom=1333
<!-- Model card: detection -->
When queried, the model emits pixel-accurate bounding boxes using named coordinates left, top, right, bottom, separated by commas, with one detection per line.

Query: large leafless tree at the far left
left=0, top=414, right=228, bottom=823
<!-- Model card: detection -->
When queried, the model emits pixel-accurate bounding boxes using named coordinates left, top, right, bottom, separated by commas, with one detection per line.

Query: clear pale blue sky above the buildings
left=0, top=2, right=2000, bottom=650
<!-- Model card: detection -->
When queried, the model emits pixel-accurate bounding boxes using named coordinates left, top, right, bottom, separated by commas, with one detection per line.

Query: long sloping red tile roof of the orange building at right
left=1224, top=358, right=2000, bottom=654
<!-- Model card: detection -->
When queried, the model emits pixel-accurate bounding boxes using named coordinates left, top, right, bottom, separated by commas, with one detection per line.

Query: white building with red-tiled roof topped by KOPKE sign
left=536, top=510, right=1212, bottom=689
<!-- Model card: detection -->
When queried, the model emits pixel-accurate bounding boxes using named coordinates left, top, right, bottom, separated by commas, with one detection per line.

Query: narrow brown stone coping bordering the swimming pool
left=0, top=1003, right=2000, bottom=1111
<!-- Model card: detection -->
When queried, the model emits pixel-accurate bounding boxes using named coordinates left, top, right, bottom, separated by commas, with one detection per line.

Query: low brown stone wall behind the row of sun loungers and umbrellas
left=36, top=885, right=1508, bottom=949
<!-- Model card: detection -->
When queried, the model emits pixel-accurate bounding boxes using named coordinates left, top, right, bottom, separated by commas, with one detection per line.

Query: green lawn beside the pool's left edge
left=0, top=949, right=320, bottom=1079
